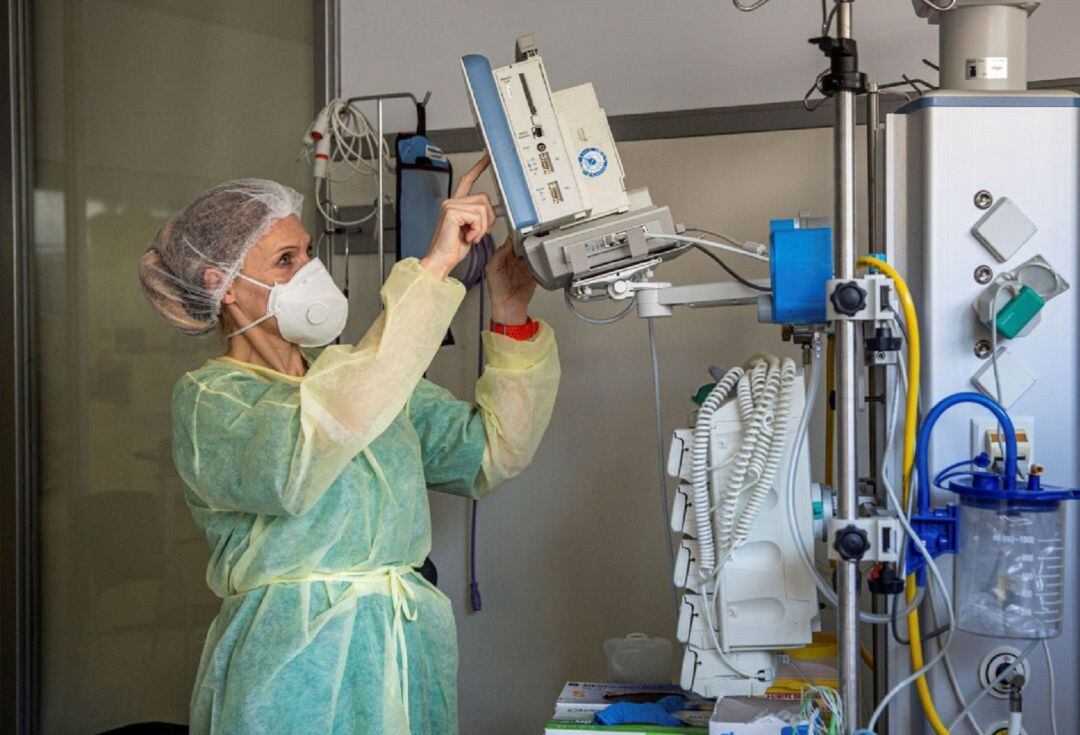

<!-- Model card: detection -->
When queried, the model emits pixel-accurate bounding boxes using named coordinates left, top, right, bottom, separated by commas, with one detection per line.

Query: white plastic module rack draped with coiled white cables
left=667, top=376, right=818, bottom=697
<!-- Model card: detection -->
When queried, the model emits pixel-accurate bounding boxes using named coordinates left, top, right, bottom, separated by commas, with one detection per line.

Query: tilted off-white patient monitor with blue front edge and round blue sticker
left=461, top=36, right=684, bottom=289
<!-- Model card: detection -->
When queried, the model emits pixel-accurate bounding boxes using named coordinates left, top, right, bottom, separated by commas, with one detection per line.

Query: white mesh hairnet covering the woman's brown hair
left=138, top=179, right=303, bottom=335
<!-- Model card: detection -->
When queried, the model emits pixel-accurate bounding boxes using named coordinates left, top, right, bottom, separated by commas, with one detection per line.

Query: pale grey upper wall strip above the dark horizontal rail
left=341, top=0, right=1080, bottom=130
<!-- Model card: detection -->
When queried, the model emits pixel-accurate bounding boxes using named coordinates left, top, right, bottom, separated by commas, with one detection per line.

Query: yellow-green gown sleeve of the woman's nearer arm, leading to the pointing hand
left=173, top=259, right=464, bottom=516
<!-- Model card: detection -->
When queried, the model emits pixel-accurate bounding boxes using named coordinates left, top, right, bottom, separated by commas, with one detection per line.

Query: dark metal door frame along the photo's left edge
left=0, top=0, right=40, bottom=735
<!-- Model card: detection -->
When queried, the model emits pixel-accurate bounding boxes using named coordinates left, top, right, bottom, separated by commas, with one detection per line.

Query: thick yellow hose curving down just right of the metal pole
left=858, top=258, right=949, bottom=735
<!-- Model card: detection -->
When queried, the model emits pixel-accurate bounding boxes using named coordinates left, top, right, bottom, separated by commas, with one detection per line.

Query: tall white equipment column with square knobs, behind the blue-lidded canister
left=886, top=92, right=1080, bottom=733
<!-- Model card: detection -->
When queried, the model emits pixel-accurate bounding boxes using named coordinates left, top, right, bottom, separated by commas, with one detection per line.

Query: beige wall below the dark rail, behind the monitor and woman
left=351, top=130, right=868, bottom=735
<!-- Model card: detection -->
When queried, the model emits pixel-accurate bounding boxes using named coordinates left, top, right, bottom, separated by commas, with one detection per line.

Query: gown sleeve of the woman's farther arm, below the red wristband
left=409, top=324, right=559, bottom=499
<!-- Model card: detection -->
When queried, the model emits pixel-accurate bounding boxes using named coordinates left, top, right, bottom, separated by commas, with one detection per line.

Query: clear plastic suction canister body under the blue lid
left=954, top=496, right=1065, bottom=638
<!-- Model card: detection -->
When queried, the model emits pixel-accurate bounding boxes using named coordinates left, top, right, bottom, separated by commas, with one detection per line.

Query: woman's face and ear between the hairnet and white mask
left=221, top=215, right=311, bottom=336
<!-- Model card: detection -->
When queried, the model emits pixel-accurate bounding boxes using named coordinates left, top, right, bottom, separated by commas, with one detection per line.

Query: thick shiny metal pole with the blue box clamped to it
left=834, top=0, right=859, bottom=732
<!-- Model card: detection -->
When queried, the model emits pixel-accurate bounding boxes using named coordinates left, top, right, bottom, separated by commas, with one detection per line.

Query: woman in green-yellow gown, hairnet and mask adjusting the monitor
left=139, top=160, right=559, bottom=735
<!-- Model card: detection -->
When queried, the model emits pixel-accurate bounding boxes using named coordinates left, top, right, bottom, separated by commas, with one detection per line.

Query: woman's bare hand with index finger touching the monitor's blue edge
left=420, top=155, right=495, bottom=280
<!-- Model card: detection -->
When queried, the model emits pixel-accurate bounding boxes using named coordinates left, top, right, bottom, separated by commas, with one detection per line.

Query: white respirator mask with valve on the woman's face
left=229, top=258, right=349, bottom=348
